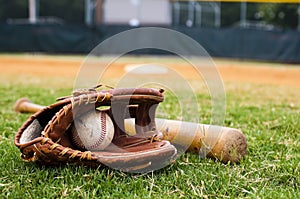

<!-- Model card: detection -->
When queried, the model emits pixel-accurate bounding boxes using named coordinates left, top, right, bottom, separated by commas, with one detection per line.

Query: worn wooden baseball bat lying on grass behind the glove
left=14, top=98, right=247, bottom=163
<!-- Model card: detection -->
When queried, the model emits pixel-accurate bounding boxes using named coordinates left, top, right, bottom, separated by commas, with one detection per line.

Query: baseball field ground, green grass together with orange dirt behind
left=0, top=54, right=300, bottom=198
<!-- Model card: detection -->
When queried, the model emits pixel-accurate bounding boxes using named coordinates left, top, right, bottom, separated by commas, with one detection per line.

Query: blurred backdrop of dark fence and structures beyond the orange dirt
left=0, top=0, right=300, bottom=63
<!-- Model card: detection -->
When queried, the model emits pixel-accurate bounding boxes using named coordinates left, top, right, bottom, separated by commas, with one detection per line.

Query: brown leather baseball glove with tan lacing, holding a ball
left=15, top=88, right=176, bottom=172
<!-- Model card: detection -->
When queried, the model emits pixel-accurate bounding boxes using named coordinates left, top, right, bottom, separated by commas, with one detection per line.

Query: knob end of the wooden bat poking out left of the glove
left=14, top=98, right=45, bottom=113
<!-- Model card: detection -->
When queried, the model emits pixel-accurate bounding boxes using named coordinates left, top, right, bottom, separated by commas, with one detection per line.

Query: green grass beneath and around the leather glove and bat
left=0, top=76, right=300, bottom=198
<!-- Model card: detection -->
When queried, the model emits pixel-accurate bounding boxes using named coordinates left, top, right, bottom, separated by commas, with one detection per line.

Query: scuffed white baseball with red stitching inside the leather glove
left=71, top=110, right=114, bottom=151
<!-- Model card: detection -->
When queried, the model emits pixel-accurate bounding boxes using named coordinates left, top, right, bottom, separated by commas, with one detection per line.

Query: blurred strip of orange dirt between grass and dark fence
left=0, top=55, right=300, bottom=88
